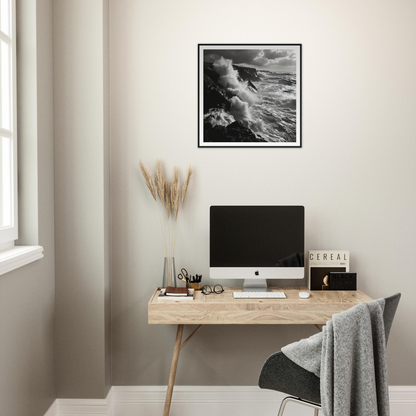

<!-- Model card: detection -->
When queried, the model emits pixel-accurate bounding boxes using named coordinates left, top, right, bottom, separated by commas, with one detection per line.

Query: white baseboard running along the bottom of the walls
left=45, top=386, right=416, bottom=416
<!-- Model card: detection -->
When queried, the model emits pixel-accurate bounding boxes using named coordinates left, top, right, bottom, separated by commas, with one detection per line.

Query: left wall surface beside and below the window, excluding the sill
left=0, top=0, right=56, bottom=416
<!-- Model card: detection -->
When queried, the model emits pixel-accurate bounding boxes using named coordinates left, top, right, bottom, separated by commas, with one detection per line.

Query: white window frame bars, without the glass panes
left=0, top=0, right=18, bottom=250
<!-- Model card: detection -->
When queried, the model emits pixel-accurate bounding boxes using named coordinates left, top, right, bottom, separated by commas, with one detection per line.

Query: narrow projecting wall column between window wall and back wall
left=53, top=0, right=111, bottom=398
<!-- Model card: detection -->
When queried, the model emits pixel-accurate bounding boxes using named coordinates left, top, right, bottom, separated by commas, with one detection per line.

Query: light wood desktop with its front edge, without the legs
left=148, top=286, right=371, bottom=325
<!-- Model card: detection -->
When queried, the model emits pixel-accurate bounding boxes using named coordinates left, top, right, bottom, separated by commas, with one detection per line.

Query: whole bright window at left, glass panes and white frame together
left=0, top=0, right=18, bottom=248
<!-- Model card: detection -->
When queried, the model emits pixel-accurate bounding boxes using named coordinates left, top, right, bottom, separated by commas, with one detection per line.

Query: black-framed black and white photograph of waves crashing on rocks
left=198, top=44, right=302, bottom=147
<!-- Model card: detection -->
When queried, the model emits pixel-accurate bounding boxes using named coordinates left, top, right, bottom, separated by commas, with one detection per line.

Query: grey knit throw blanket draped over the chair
left=282, top=299, right=390, bottom=416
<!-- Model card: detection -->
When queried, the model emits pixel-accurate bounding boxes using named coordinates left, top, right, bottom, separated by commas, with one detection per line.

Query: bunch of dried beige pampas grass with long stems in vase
left=140, top=159, right=193, bottom=286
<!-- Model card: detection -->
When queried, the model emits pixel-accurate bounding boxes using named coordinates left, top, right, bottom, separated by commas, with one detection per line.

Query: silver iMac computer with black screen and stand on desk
left=209, top=205, right=305, bottom=291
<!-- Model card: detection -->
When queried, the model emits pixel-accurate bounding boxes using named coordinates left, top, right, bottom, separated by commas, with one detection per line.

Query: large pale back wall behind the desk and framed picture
left=110, top=0, right=416, bottom=385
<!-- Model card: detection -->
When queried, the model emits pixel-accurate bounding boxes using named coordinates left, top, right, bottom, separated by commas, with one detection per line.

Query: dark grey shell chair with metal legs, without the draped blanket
left=259, top=293, right=401, bottom=416
